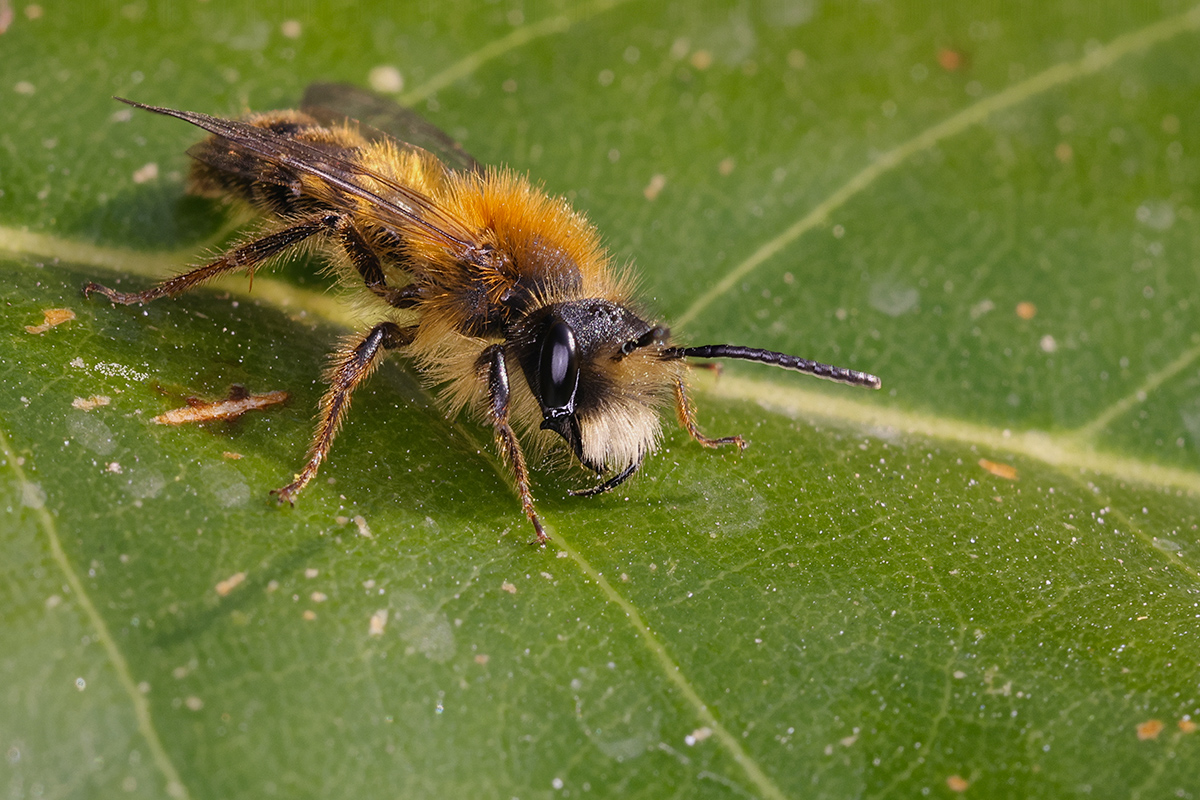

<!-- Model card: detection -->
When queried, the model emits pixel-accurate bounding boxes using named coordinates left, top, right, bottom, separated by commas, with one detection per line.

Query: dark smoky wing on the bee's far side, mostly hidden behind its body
left=300, top=83, right=484, bottom=173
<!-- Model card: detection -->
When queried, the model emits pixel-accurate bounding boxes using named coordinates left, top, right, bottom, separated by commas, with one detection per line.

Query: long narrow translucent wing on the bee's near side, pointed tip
left=116, top=97, right=478, bottom=254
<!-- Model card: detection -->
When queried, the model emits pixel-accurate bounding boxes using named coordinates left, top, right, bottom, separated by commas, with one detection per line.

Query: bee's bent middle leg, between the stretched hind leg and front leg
left=271, top=323, right=415, bottom=504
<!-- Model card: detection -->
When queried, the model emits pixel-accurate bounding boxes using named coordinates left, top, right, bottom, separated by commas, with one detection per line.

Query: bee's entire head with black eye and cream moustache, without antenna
left=510, top=300, right=679, bottom=473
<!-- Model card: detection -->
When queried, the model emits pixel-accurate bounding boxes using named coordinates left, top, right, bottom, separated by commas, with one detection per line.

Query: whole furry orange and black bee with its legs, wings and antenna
left=84, top=84, right=880, bottom=543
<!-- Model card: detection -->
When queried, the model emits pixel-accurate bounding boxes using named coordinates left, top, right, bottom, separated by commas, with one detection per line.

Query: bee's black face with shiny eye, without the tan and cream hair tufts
left=509, top=300, right=667, bottom=471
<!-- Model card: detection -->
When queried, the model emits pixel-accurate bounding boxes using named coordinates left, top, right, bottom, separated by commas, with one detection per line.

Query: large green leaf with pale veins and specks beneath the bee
left=0, top=0, right=1200, bottom=798
